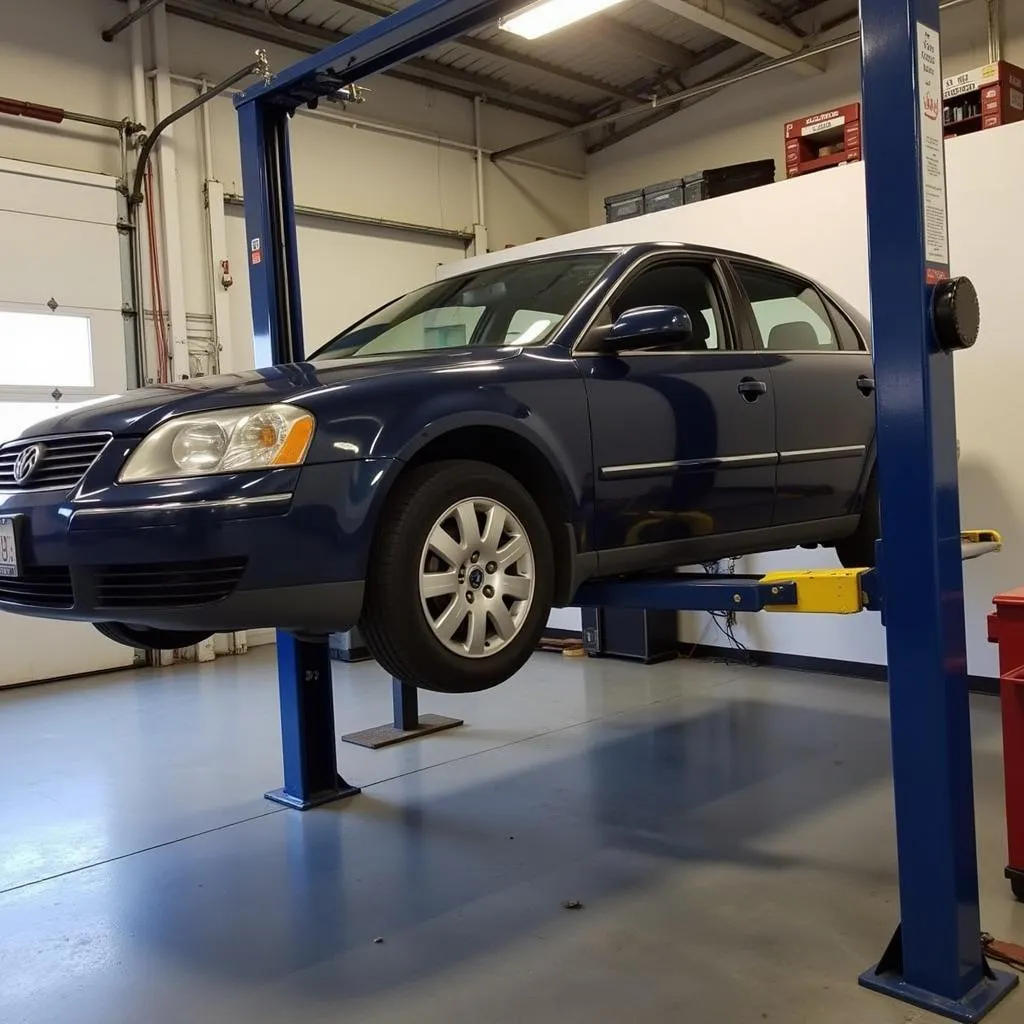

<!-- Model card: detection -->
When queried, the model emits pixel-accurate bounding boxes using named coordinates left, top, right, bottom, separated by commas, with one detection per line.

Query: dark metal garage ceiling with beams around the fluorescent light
left=167, top=0, right=857, bottom=150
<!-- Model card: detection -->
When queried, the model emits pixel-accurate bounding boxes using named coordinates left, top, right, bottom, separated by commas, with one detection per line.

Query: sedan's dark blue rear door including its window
left=732, top=261, right=874, bottom=526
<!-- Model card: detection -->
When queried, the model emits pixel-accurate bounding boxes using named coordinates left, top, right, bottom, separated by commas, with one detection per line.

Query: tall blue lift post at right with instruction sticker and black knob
left=860, top=0, right=1017, bottom=1021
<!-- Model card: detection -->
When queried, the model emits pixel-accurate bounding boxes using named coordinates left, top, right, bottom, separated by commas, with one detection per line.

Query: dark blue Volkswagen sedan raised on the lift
left=0, top=244, right=878, bottom=692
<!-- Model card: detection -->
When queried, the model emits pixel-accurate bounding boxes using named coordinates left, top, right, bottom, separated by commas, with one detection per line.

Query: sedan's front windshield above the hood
left=312, top=253, right=612, bottom=361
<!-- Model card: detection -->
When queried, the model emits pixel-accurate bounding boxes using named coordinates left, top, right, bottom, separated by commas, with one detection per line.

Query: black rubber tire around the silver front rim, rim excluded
left=359, top=459, right=554, bottom=693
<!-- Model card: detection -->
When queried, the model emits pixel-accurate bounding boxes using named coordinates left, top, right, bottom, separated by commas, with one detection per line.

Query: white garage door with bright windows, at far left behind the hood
left=0, top=160, right=132, bottom=686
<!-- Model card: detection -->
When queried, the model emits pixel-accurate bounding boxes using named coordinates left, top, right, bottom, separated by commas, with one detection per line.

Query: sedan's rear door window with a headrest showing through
left=736, top=265, right=840, bottom=352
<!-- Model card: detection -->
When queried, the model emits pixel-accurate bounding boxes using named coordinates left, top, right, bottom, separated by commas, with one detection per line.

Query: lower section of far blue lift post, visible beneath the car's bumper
left=265, top=633, right=359, bottom=811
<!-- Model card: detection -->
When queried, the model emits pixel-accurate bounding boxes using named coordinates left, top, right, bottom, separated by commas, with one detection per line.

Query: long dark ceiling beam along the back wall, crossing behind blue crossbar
left=161, top=0, right=588, bottom=126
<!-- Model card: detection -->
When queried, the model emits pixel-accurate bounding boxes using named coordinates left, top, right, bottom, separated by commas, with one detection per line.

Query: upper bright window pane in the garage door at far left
left=0, top=309, right=93, bottom=388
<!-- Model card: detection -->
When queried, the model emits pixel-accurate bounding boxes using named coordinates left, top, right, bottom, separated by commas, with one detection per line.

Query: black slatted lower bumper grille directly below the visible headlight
left=96, top=558, right=246, bottom=608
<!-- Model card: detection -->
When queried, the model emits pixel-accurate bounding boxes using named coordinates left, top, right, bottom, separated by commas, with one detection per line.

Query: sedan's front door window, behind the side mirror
left=602, top=262, right=725, bottom=352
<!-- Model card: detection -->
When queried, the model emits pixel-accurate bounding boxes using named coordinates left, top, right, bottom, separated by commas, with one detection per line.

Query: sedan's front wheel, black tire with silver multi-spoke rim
left=361, top=460, right=554, bottom=693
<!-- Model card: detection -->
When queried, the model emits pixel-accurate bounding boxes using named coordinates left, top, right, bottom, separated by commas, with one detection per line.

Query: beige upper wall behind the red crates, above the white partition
left=587, top=0, right=1024, bottom=224
